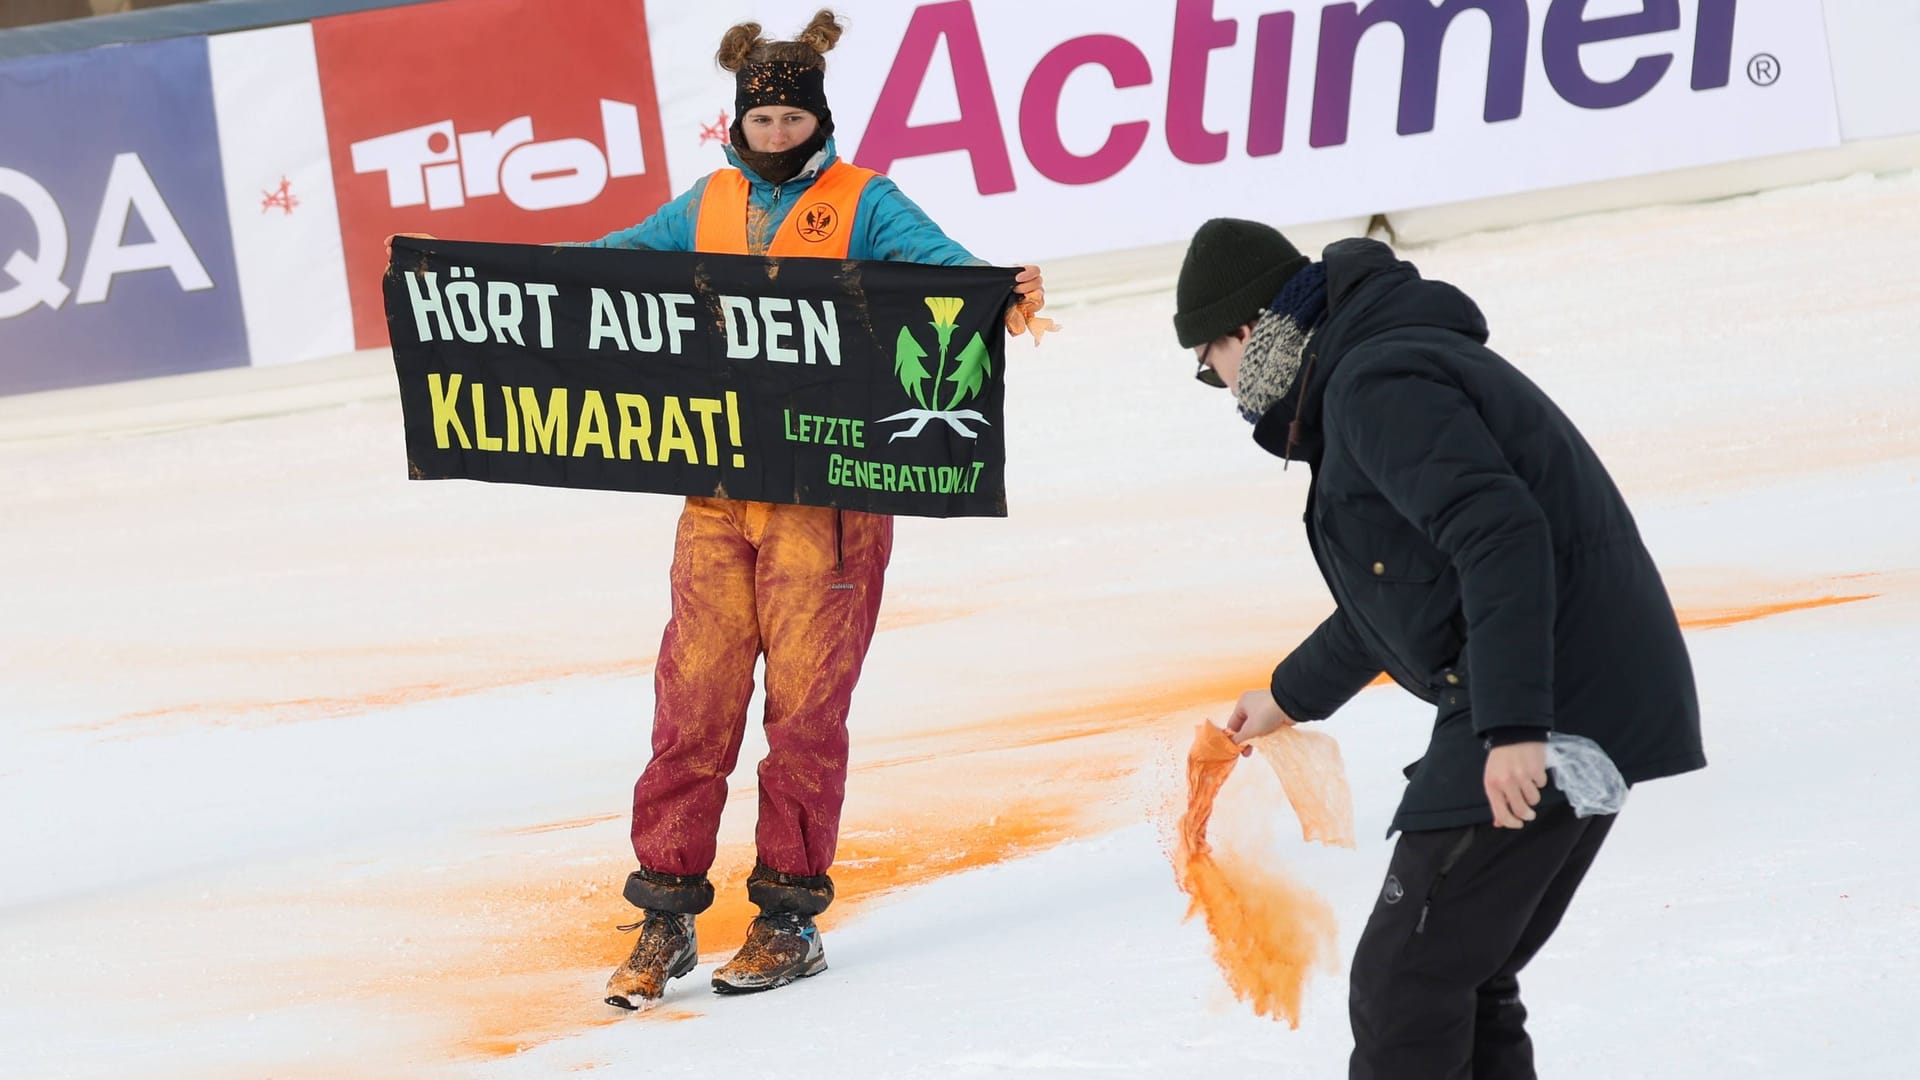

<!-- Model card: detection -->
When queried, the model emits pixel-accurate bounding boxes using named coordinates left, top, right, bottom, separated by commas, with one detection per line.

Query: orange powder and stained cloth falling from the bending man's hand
left=1173, top=723, right=1354, bottom=1028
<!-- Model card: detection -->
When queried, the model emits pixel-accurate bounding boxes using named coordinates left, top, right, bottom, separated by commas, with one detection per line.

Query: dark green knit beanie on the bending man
left=1173, top=217, right=1308, bottom=348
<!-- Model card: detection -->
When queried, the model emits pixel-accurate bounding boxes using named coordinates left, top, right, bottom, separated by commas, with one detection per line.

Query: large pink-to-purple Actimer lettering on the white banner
left=852, top=0, right=1759, bottom=194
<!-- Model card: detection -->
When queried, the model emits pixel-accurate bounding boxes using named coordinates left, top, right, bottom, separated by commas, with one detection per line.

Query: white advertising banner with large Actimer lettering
left=647, top=0, right=1839, bottom=261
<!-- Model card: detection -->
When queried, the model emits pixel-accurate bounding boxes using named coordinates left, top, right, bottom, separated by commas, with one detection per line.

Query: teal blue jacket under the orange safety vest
left=588, top=138, right=987, bottom=267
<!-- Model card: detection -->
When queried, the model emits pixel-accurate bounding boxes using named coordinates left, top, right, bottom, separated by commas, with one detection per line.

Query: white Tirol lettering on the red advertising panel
left=353, top=98, right=647, bottom=209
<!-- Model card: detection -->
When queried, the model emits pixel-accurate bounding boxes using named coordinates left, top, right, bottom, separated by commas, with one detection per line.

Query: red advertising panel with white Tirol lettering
left=313, top=0, right=672, bottom=348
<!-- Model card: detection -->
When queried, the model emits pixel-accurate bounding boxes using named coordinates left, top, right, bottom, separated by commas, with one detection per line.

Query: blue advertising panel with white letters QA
left=0, top=38, right=248, bottom=394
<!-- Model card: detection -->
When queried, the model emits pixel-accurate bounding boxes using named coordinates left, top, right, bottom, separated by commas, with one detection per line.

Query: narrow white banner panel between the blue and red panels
left=207, top=23, right=357, bottom=367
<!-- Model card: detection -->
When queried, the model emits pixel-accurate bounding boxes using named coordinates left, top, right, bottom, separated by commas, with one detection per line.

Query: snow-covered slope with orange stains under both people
left=0, top=175, right=1920, bottom=1080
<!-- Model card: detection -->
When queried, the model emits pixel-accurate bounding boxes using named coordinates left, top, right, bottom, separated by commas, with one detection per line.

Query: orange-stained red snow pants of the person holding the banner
left=634, top=498, right=893, bottom=876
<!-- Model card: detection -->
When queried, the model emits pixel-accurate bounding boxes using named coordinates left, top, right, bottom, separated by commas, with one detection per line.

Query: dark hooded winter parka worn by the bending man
left=1254, top=240, right=1707, bottom=832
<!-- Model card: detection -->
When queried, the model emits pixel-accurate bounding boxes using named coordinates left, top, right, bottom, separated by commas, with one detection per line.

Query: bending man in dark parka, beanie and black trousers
left=1173, top=219, right=1707, bottom=1080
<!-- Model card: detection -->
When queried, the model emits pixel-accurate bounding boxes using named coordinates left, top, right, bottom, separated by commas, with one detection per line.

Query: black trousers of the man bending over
left=1348, top=803, right=1613, bottom=1080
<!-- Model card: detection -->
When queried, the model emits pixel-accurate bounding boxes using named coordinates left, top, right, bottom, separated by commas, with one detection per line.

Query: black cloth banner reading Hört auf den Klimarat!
left=386, top=238, right=1018, bottom=517
